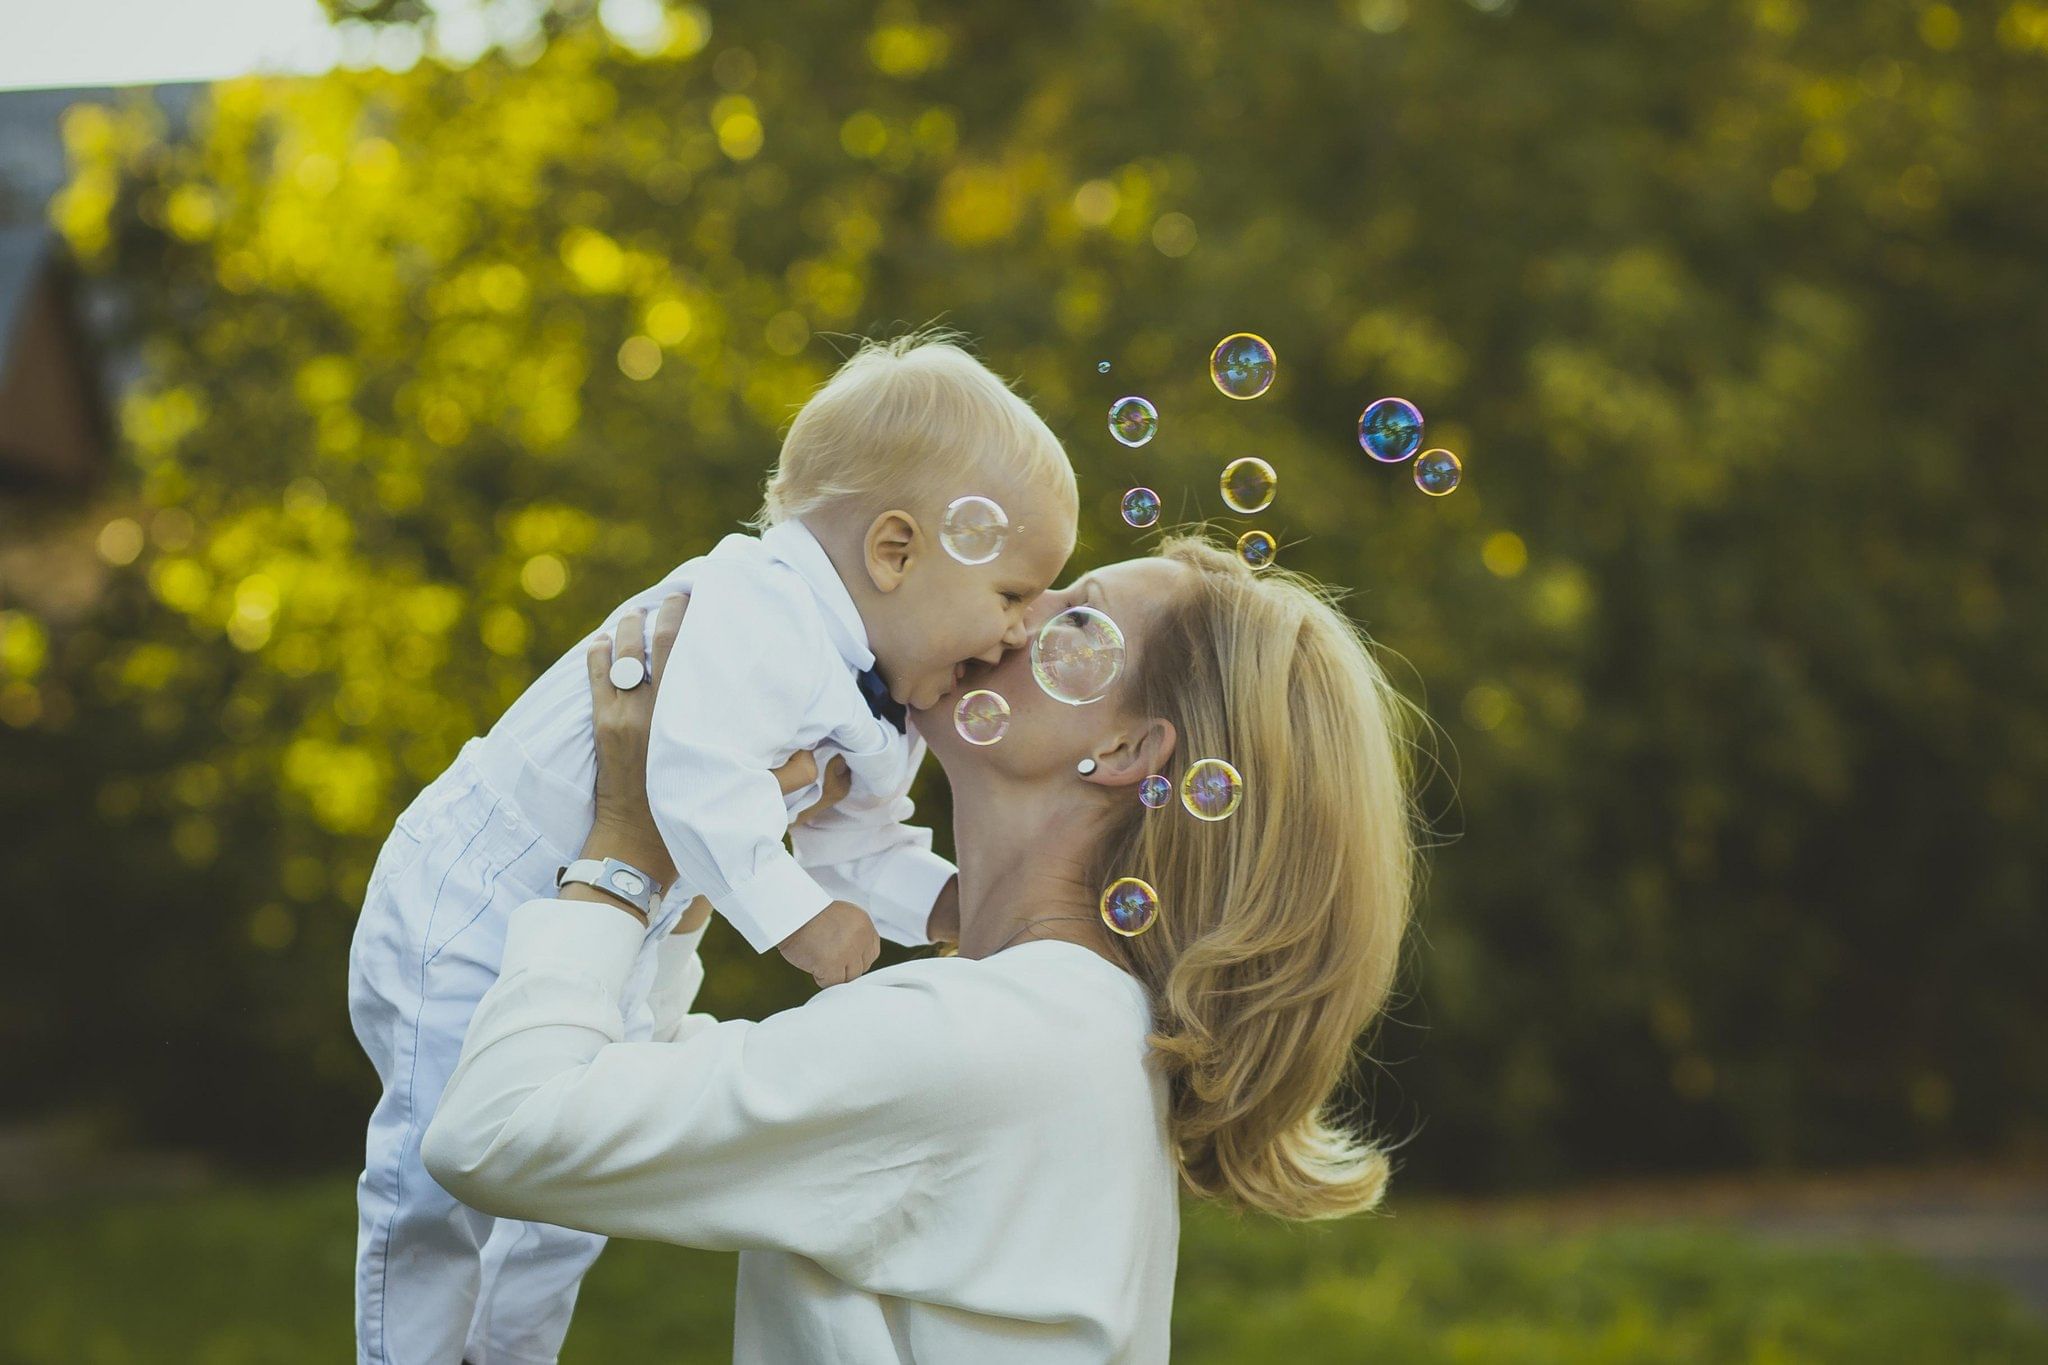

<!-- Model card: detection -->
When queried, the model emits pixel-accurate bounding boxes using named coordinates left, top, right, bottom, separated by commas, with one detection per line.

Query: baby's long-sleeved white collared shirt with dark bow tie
left=485, top=520, right=954, bottom=952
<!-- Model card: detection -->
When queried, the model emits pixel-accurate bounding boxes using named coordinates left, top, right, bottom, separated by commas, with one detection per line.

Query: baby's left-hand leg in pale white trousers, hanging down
left=348, top=763, right=557, bottom=1365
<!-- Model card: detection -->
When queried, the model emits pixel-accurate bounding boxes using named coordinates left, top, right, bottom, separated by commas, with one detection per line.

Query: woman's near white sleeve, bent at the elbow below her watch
left=422, top=900, right=991, bottom=1281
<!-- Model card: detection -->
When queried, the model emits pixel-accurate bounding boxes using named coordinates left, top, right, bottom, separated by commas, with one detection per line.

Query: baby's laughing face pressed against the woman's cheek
left=868, top=482, right=1075, bottom=710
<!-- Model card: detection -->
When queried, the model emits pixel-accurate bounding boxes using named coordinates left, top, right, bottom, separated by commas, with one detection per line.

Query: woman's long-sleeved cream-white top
left=422, top=900, right=1180, bottom=1365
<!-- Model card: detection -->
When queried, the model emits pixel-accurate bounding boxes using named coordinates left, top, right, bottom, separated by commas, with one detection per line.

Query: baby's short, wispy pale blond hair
left=752, top=327, right=1077, bottom=530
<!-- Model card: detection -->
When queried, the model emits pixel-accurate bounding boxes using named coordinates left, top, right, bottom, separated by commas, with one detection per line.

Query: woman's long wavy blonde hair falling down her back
left=1090, top=534, right=1419, bottom=1218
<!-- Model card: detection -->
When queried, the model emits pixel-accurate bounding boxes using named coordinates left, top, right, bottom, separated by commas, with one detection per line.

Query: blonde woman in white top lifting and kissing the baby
left=424, top=538, right=1413, bottom=1365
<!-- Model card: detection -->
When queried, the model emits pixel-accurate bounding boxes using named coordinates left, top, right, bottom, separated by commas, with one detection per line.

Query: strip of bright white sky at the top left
left=0, top=0, right=664, bottom=90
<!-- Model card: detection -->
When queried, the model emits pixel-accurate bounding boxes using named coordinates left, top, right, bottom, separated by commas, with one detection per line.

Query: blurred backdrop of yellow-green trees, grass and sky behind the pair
left=0, top=0, right=2048, bottom=1361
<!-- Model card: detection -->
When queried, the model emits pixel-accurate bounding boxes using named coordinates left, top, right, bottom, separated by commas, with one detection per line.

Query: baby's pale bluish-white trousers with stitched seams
left=348, top=739, right=671, bottom=1365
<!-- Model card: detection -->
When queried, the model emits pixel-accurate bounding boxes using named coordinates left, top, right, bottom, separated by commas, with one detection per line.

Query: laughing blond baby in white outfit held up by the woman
left=348, top=336, right=1077, bottom=1365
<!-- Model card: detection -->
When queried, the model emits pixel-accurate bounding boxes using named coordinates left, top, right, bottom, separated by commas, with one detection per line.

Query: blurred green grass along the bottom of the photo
left=0, top=1179, right=2048, bottom=1365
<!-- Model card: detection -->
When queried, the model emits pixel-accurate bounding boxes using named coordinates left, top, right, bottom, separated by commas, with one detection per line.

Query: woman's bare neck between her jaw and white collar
left=952, top=786, right=1122, bottom=966
